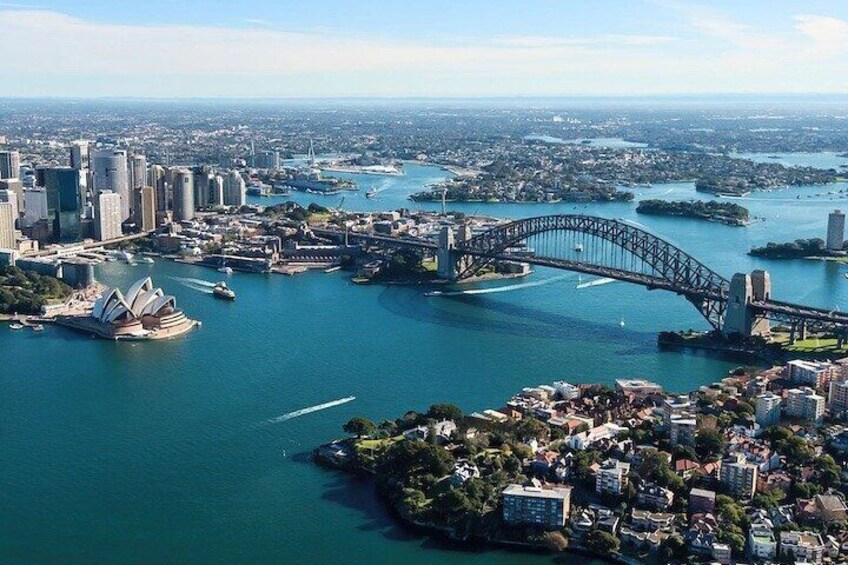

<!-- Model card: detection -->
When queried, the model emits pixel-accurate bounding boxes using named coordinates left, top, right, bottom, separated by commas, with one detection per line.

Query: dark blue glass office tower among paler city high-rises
left=43, top=167, right=85, bottom=243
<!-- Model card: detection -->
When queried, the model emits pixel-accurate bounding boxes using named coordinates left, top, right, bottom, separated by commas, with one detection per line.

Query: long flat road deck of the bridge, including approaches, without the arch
left=312, top=228, right=848, bottom=330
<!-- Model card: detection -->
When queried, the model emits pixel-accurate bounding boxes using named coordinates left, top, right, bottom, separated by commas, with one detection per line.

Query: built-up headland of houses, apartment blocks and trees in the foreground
left=313, top=359, right=848, bottom=564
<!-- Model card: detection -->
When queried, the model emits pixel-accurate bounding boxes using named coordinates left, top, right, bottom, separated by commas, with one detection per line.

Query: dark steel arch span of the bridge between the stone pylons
left=456, top=215, right=730, bottom=329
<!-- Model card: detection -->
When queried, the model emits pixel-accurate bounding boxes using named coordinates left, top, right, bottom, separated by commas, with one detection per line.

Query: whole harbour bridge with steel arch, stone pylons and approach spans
left=313, top=214, right=848, bottom=339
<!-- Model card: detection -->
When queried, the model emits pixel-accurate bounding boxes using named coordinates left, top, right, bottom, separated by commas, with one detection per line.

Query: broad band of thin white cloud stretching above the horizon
left=0, top=8, right=848, bottom=97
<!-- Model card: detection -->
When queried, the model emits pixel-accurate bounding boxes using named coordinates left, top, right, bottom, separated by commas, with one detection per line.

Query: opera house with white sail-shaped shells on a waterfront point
left=57, top=277, right=198, bottom=339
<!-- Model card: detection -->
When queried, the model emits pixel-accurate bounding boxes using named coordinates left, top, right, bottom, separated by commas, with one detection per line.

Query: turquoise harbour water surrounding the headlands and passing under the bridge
left=0, top=159, right=848, bottom=565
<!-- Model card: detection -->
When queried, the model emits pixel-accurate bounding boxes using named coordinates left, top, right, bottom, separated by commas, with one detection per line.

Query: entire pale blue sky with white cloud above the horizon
left=0, top=0, right=848, bottom=98
